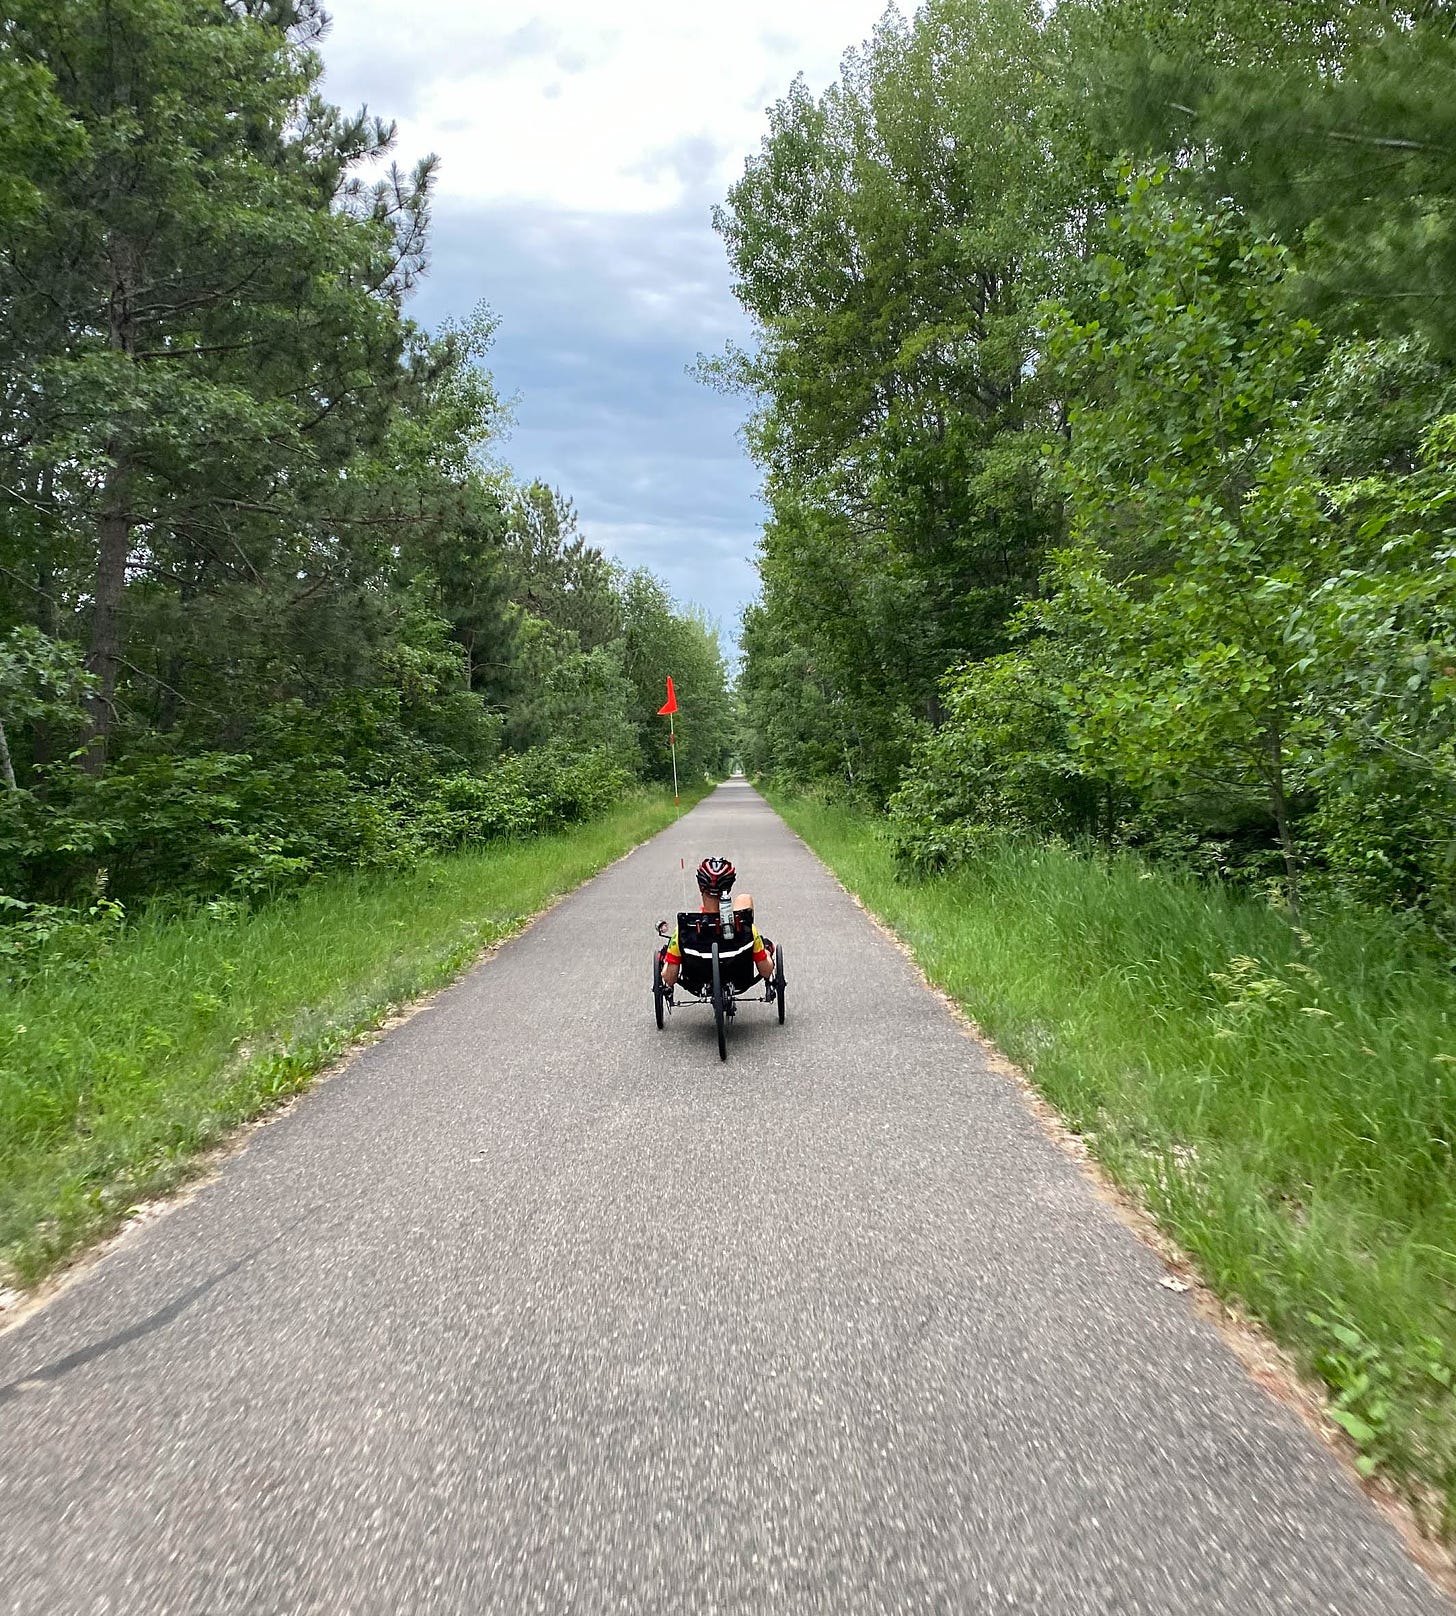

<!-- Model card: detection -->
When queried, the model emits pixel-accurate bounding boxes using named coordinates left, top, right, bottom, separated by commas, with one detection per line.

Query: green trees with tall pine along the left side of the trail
left=0, top=0, right=732, bottom=947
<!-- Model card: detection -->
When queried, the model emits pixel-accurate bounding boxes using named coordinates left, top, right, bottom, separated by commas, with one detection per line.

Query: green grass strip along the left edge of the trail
left=0, top=790, right=706, bottom=1285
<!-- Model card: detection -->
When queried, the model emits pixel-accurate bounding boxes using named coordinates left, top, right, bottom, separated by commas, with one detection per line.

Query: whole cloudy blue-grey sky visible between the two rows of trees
left=323, top=0, right=884, bottom=656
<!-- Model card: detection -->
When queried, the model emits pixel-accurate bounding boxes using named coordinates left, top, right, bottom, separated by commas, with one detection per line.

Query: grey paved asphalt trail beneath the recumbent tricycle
left=0, top=782, right=1450, bottom=1616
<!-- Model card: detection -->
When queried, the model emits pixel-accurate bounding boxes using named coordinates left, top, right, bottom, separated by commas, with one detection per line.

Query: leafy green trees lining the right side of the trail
left=723, top=0, right=1456, bottom=941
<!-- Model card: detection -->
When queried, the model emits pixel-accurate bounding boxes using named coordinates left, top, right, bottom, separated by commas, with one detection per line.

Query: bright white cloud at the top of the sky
left=325, top=0, right=884, bottom=213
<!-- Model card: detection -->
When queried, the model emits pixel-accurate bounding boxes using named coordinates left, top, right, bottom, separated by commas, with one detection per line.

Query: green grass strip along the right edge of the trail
left=774, top=798, right=1456, bottom=1538
